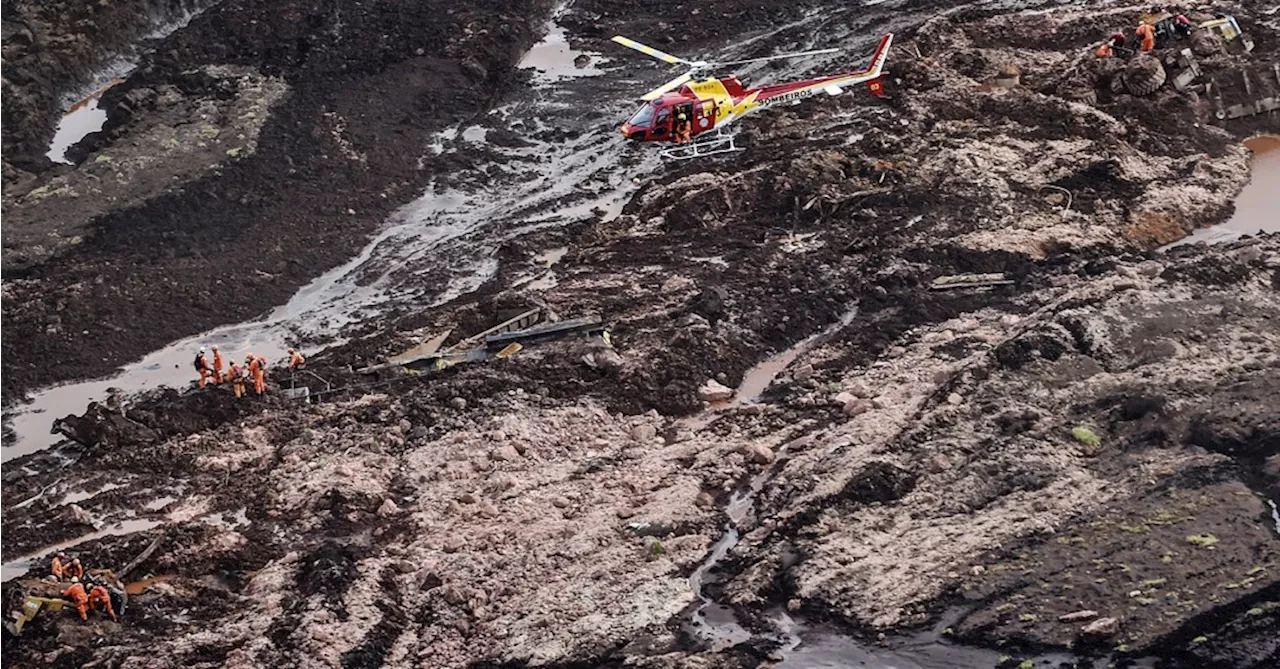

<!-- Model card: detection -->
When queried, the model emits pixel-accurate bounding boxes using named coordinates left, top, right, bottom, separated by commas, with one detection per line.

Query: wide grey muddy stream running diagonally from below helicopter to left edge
left=0, top=6, right=640, bottom=462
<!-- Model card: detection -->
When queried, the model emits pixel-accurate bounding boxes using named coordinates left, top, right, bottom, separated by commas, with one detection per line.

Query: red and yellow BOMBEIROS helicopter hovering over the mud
left=613, top=33, right=893, bottom=160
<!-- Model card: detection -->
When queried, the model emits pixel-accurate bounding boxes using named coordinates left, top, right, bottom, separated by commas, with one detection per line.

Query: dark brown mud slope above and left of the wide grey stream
left=0, top=0, right=550, bottom=404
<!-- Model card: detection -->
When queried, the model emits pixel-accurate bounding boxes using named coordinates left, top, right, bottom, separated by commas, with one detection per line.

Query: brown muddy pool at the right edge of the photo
left=1164, top=134, right=1280, bottom=248
